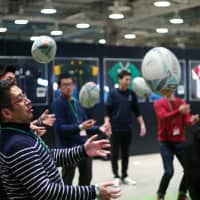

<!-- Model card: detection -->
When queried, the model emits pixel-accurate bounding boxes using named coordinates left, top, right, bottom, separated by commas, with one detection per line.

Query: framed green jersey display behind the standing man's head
left=103, top=58, right=146, bottom=102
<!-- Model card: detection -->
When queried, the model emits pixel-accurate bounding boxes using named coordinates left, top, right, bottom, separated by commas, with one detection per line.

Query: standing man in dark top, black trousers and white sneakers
left=105, top=70, right=146, bottom=186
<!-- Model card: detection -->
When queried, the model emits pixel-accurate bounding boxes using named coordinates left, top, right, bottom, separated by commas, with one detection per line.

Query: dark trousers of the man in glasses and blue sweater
left=62, top=158, right=92, bottom=185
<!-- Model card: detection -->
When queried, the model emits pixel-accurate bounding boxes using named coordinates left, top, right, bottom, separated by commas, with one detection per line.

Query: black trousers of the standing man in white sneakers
left=110, top=131, right=132, bottom=178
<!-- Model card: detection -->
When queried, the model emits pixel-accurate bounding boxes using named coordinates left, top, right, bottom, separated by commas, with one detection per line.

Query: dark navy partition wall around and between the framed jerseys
left=0, top=40, right=200, bottom=154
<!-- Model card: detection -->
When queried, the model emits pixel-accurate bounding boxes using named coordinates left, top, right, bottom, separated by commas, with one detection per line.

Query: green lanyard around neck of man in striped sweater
left=1, top=127, right=49, bottom=153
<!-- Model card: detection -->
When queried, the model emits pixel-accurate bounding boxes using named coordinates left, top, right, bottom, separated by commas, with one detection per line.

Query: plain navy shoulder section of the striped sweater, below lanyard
left=0, top=134, right=38, bottom=157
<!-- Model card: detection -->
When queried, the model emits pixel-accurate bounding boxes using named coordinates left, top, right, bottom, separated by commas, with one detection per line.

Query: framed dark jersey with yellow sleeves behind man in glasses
left=53, top=57, right=99, bottom=98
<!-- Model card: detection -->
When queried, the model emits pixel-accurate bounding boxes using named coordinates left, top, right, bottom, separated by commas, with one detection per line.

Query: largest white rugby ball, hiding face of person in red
left=141, top=47, right=181, bottom=92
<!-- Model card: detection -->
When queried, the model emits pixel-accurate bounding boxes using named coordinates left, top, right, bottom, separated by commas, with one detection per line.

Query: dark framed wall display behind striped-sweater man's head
left=0, top=56, right=48, bottom=106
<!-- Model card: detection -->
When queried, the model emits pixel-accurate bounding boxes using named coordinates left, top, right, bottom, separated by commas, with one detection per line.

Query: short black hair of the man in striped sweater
left=0, top=80, right=15, bottom=121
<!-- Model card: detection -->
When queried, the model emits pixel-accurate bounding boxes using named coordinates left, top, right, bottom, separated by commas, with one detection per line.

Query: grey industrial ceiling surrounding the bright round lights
left=0, top=0, right=200, bottom=48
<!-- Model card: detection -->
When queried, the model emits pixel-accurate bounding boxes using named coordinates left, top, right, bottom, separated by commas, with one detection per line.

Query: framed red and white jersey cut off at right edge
left=189, top=60, right=200, bottom=101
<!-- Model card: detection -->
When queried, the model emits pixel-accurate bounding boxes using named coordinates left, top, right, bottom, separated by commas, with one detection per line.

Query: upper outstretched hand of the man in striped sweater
left=84, top=135, right=110, bottom=157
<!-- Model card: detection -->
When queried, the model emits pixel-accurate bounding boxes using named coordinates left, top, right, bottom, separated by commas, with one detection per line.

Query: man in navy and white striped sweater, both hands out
left=0, top=80, right=120, bottom=200
